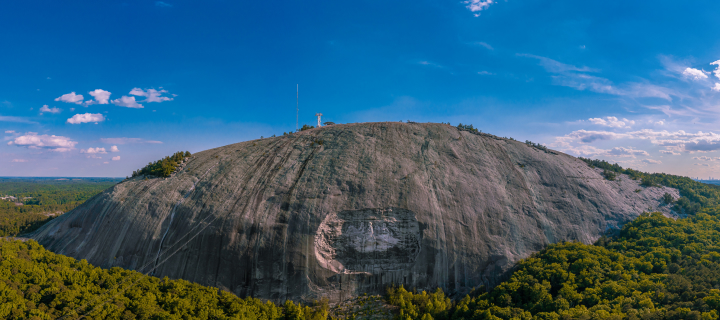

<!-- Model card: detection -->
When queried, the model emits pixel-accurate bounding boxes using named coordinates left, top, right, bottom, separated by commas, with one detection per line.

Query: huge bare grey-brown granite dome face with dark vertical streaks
left=32, top=123, right=679, bottom=301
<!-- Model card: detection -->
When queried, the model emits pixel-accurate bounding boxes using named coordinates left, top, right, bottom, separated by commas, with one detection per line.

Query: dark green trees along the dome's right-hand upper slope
left=578, top=157, right=720, bottom=214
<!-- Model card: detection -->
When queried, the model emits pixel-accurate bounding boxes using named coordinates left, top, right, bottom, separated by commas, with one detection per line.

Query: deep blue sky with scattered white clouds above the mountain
left=0, top=0, right=720, bottom=178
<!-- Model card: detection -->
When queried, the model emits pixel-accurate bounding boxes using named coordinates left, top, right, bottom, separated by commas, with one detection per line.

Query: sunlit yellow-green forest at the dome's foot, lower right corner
left=388, top=208, right=720, bottom=320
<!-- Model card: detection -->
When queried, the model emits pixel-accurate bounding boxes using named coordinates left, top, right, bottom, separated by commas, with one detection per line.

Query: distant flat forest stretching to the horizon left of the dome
left=0, top=178, right=121, bottom=236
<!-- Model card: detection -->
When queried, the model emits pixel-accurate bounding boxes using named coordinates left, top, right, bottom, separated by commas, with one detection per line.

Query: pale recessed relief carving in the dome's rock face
left=315, top=208, right=421, bottom=274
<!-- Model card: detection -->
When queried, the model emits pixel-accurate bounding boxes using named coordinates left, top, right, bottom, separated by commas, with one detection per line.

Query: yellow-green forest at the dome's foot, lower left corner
left=0, top=239, right=329, bottom=320
